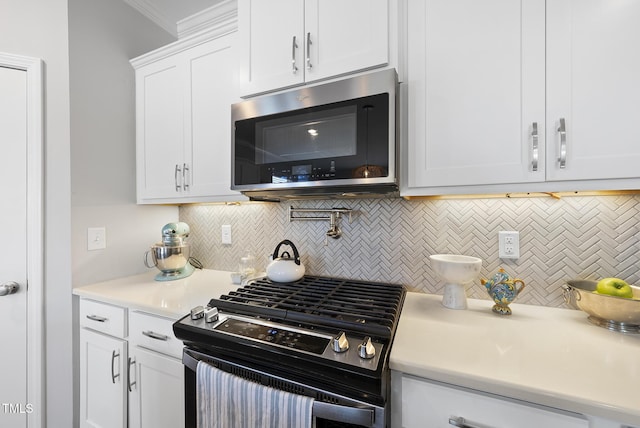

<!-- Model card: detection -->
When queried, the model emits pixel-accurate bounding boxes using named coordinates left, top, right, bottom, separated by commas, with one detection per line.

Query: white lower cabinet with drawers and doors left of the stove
left=79, top=299, right=184, bottom=428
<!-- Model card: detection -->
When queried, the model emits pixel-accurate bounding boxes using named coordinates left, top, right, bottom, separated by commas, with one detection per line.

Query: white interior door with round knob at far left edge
left=0, top=67, right=28, bottom=428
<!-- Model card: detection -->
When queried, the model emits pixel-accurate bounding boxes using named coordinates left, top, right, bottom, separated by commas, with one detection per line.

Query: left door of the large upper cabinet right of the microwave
left=405, top=0, right=545, bottom=188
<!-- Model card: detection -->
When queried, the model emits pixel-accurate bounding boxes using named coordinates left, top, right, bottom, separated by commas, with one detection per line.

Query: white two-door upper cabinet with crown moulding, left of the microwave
left=132, top=33, right=246, bottom=204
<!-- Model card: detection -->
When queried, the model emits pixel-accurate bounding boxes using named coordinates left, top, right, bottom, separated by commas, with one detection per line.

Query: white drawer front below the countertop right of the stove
left=402, top=375, right=589, bottom=428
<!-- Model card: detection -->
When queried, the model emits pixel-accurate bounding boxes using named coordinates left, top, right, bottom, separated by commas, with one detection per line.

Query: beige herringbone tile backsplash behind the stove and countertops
left=180, top=195, right=640, bottom=306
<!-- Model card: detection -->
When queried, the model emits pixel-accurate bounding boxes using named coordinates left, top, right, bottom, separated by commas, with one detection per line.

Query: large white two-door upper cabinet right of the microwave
left=408, top=0, right=640, bottom=196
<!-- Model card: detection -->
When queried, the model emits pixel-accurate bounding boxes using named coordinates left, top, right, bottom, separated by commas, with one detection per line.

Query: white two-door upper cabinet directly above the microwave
left=238, top=0, right=392, bottom=96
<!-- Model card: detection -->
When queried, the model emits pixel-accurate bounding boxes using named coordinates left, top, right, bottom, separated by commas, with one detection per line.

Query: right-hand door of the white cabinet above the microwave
left=303, top=0, right=389, bottom=82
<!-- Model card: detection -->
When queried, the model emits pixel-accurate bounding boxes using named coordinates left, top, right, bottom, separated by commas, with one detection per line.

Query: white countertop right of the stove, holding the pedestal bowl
left=390, top=293, right=640, bottom=426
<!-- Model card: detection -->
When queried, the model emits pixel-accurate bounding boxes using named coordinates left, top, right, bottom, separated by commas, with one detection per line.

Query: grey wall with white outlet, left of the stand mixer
left=69, top=0, right=178, bottom=287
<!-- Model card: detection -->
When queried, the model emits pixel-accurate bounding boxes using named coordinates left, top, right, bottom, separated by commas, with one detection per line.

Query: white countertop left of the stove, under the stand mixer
left=73, top=269, right=239, bottom=319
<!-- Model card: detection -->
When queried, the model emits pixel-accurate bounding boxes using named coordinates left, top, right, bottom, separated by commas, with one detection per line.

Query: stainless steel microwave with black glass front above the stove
left=231, top=69, right=398, bottom=200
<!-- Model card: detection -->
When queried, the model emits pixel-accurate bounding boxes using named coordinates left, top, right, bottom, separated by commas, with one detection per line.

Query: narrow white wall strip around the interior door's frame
left=0, top=0, right=73, bottom=427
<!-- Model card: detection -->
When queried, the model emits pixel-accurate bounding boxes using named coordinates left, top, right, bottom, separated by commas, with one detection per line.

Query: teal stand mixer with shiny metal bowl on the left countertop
left=144, top=222, right=199, bottom=281
